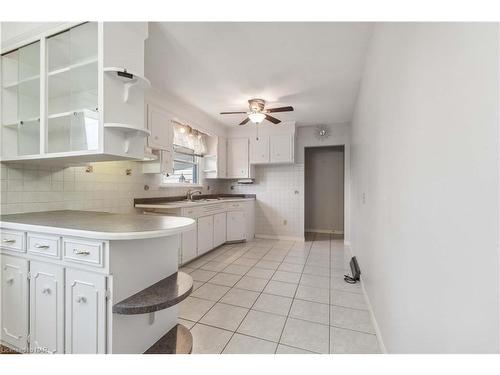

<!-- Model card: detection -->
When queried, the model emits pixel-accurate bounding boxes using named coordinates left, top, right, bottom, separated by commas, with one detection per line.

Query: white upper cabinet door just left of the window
left=148, top=104, right=174, bottom=150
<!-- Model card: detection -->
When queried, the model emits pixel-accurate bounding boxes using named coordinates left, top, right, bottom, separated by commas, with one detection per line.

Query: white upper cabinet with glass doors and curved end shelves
left=1, top=22, right=149, bottom=164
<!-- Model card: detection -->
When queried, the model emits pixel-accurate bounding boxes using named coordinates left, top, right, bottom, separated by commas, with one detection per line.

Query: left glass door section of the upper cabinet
left=1, top=41, right=40, bottom=157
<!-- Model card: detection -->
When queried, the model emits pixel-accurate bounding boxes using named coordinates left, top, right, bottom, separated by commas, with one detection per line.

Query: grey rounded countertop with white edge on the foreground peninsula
left=0, top=211, right=196, bottom=240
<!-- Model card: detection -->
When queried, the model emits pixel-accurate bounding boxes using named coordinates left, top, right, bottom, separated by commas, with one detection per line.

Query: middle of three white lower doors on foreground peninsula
left=30, top=261, right=64, bottom=354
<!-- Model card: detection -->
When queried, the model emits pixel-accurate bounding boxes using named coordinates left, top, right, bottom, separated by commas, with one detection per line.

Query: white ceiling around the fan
left=146, top=22, right=371, bottom=126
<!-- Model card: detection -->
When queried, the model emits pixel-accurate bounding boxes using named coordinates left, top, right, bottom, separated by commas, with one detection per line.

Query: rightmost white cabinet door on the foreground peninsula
left=65, top=269, right=106, bottom=354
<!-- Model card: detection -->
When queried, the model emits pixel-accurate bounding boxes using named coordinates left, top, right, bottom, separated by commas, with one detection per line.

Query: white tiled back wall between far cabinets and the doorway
left=218, top=164, right=304, bottom=238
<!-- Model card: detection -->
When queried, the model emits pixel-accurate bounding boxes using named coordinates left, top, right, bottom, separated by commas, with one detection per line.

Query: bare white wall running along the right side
left=351, top=23, right=499, bottom=353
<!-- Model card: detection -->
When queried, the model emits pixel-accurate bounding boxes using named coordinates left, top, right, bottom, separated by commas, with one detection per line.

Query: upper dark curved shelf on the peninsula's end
left=113, top=272, right=193, bottom=315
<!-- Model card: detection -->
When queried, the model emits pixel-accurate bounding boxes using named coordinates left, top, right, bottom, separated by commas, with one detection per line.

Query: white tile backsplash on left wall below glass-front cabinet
left=0, top=161, right=218, bottom=214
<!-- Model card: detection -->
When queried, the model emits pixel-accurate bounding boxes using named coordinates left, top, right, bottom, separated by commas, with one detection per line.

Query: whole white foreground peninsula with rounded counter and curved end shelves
left=0, top=211, right=195, bottom=353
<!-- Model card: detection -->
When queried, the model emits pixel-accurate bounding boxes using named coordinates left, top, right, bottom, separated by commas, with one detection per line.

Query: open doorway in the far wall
left=304, top=146, right=345, bottom=239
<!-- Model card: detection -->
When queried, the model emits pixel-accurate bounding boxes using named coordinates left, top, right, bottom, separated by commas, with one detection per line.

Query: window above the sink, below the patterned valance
left=163, top=145, right=201, bottom=184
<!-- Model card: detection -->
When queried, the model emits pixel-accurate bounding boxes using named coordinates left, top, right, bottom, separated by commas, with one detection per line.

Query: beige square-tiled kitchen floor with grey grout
left=179, top=234, right=379, bottom=354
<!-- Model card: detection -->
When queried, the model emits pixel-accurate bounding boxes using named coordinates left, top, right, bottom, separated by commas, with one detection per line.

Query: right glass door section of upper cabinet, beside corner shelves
left=46, top=22, right=99, bottom=153
